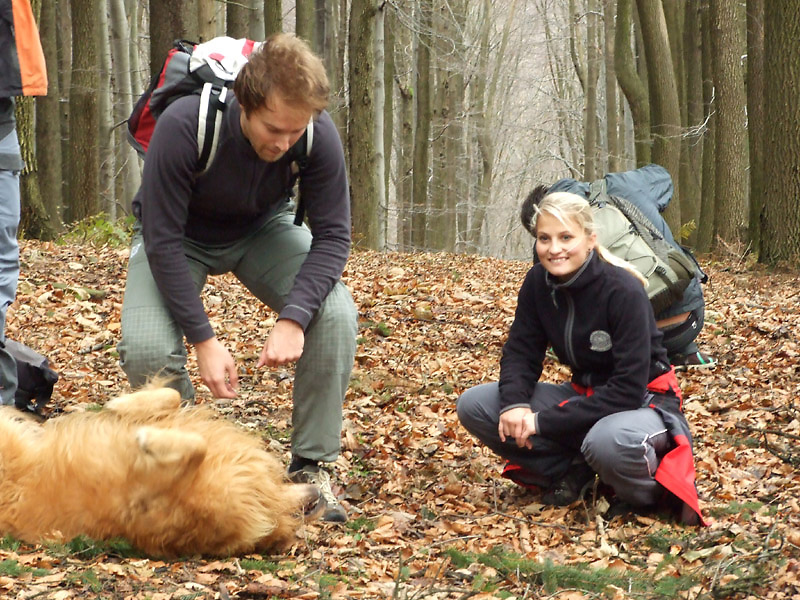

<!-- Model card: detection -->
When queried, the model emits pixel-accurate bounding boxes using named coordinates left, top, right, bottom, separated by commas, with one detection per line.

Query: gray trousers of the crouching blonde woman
left=457, top=383, right=671, bottom=506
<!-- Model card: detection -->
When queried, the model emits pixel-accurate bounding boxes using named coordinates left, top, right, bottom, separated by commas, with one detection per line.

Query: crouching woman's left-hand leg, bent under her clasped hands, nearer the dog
left=456, top=383, right=592, bottom=504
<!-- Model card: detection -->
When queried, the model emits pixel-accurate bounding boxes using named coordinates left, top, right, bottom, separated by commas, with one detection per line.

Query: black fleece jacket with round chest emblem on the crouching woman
left=500, top=252, right=670, bottom=442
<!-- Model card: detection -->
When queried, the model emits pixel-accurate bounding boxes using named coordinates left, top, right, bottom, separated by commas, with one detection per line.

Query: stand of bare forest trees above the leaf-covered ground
left=18, top=0, right=800, bottom=265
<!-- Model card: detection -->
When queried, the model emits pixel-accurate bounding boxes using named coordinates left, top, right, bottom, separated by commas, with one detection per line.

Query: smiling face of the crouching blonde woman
left=536, top=213, right=597, bottom=281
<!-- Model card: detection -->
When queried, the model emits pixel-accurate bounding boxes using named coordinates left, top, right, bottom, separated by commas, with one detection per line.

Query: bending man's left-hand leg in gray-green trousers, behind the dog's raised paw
left=117, top=229, right=207, bottom=402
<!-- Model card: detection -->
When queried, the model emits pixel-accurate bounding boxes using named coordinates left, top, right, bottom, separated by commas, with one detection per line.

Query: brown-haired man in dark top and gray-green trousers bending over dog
left=118, top=34, right=357, bottom=521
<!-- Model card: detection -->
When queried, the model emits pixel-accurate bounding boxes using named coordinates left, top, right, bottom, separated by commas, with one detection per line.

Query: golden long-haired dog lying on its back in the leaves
left=0, top=387, right=324, bottom=557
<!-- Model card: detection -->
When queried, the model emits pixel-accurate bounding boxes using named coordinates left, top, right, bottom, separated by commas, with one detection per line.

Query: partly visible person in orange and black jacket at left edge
left=0, top=0, right=47, bottom=404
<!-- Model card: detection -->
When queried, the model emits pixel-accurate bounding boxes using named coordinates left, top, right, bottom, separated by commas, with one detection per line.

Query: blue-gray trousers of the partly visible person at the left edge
left=0, top=129, right=19, bottom=404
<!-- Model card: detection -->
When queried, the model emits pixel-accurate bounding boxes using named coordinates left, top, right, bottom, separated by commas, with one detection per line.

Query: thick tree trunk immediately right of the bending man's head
left=348, top=0, right=384, bottom=249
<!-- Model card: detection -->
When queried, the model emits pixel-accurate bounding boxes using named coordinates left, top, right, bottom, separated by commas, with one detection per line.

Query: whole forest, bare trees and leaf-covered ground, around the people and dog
left=0, top=0, right=800, bottom=600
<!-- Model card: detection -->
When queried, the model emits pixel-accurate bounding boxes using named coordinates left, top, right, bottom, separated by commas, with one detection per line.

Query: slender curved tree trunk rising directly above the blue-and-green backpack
left=614, top=0, right=652, bottom=167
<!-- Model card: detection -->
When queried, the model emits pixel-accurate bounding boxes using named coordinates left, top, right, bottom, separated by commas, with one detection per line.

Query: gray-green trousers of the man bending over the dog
left=117, top=211, right=357, bottom=462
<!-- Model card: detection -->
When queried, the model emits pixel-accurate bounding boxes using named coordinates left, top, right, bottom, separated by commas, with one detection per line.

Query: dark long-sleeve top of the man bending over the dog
left=133, top=96, right=350, bottom=343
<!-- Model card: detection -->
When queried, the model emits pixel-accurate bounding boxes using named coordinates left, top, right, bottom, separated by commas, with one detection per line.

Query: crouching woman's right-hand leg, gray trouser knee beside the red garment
left=581, top=408, right=671, bottom=507
